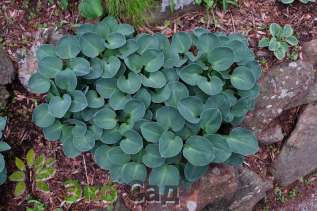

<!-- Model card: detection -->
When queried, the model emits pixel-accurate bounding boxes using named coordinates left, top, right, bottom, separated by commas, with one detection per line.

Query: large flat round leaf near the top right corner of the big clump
left=208, top=47, right=235, bottom=71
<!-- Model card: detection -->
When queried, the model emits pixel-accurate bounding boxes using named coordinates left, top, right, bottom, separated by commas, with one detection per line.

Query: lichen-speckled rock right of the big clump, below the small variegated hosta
left=243, top=61, right=315, bottom=143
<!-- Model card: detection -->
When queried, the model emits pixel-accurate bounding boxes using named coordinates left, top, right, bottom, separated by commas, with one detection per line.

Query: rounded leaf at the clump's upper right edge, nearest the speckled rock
left=230, top=66, right=256, bottom=90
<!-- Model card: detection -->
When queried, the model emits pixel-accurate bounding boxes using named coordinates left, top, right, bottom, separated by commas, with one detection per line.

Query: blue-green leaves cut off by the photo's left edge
left=0, top=117, right=11, bottom=185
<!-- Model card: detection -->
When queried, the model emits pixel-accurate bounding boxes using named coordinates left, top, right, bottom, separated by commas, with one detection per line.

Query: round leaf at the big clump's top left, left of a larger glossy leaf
left=56, top=35, right=81, bottom=59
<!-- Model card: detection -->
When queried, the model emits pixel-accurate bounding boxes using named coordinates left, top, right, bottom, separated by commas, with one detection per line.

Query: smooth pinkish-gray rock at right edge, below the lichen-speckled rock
left=272, top=104, right=317, bottom=186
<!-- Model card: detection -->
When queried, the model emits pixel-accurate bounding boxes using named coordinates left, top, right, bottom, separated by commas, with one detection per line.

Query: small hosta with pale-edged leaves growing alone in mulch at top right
left=259, top=23, right=298, bottom=60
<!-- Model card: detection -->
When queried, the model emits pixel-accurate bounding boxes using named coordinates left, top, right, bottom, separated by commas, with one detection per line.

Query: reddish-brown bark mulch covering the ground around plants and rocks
left=0, top=0, right=317, bottom=210
